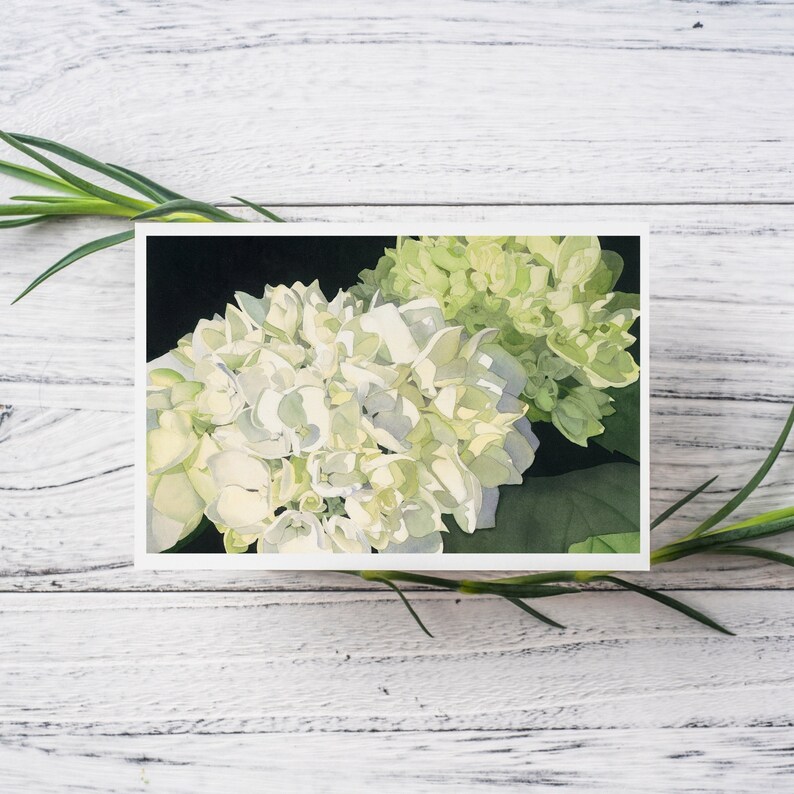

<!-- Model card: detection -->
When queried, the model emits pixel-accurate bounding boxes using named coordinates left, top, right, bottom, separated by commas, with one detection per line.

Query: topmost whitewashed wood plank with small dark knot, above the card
left=0, top=0, right=794, bottom=203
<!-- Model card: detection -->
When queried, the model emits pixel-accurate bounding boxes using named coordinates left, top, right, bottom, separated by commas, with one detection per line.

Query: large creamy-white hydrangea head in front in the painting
left=147, top=282, right=537, bottom=553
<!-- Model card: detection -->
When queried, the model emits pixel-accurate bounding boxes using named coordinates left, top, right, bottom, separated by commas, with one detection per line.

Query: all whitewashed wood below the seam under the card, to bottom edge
left=0, top=592, right=794, bottom=792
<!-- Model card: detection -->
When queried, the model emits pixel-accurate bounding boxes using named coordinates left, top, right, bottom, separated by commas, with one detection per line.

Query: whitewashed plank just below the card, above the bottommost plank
left=0, top=592, right=794, bottom=732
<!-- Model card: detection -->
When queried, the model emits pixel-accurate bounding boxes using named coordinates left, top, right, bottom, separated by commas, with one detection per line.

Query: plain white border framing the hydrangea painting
left=135, top=219, right=650, bottom=571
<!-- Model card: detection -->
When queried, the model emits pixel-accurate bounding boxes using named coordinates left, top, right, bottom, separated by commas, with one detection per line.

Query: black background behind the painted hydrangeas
left=146, top=236, right=640, bottom=553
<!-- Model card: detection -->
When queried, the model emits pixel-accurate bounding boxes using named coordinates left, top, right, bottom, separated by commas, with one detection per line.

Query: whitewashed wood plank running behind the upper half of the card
left=0, top=205, right=794, bottom=410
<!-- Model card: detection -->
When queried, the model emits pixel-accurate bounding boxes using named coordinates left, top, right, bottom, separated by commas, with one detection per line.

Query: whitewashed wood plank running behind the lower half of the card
left=0, top=400, right=794, bottom=591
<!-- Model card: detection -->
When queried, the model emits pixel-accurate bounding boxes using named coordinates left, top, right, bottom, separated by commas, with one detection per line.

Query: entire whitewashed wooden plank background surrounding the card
left=0, top=0, right=794, bottom=794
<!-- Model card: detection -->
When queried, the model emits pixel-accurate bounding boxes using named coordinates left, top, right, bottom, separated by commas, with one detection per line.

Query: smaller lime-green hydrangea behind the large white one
left=354, top=236, right=639, bottom=446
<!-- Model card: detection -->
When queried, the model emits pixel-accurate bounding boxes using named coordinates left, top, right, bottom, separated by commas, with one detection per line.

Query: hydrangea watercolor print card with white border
left=136, top=224, right=649, bottom=570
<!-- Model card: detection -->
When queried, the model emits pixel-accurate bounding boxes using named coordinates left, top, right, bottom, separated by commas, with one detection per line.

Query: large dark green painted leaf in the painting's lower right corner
left=444, top=463, right=640, bottom=554
